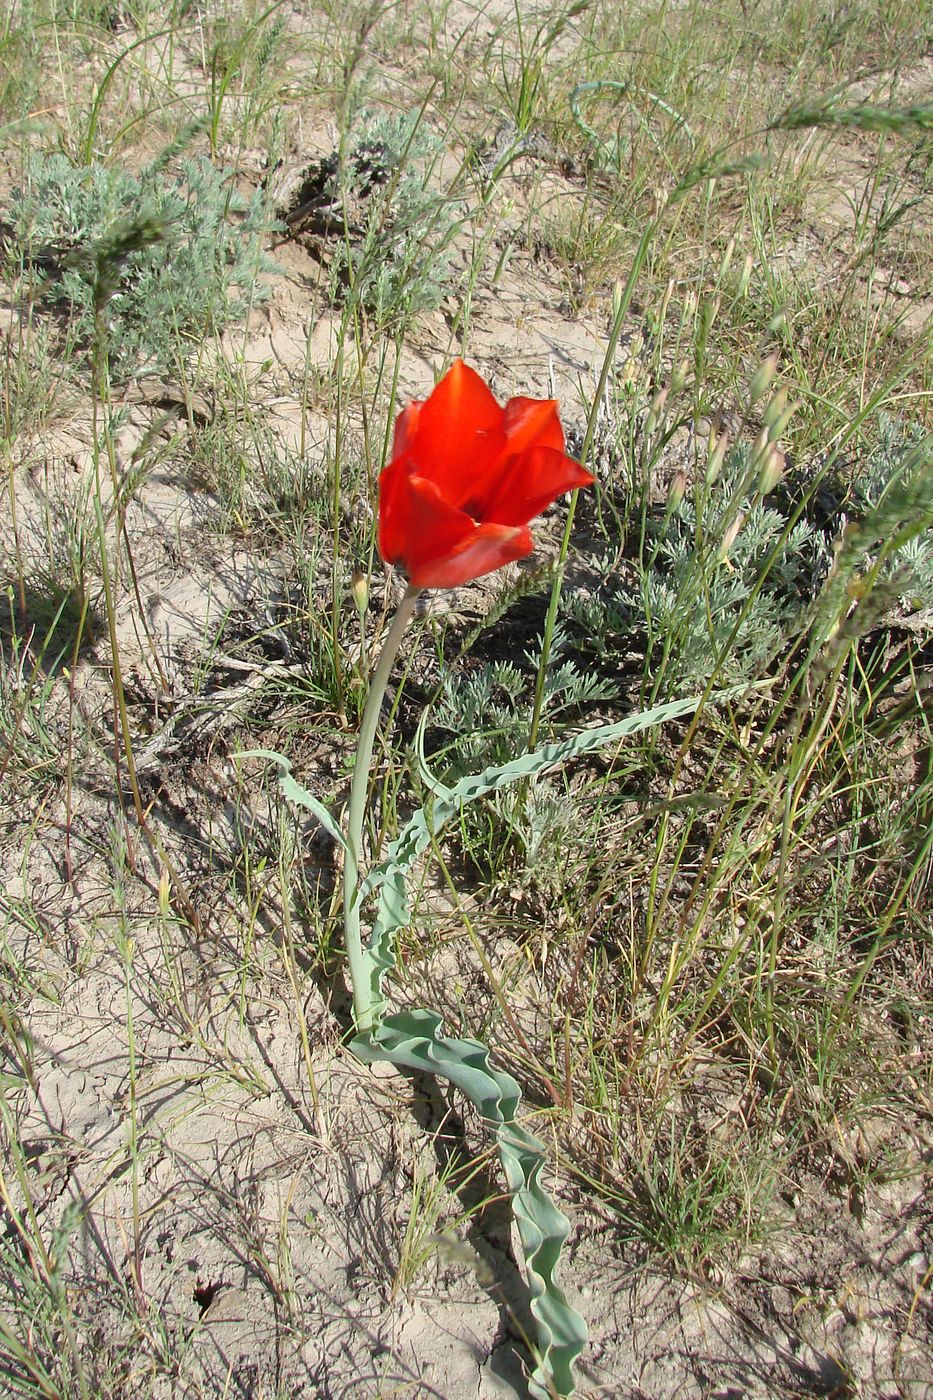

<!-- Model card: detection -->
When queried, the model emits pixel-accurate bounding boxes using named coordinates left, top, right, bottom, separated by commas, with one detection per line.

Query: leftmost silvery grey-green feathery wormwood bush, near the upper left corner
left=7, top=153, right=272, bottom=381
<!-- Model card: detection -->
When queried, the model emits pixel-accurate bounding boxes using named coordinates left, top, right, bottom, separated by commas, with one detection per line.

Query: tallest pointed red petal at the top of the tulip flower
left=410, top=360, right=504, bottom=505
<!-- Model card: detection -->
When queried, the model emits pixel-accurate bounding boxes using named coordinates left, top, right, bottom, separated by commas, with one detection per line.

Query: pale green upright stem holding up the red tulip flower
left=343, top=588, right=420, bottom=1033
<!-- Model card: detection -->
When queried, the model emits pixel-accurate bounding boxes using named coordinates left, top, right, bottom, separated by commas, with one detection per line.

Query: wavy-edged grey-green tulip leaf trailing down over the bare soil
left=350, top=1009, right=587, bottom=1400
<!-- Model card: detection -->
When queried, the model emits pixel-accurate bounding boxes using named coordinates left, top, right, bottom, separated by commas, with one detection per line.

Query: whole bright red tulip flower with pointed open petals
left=380, top=360, right=593, bottom=588
